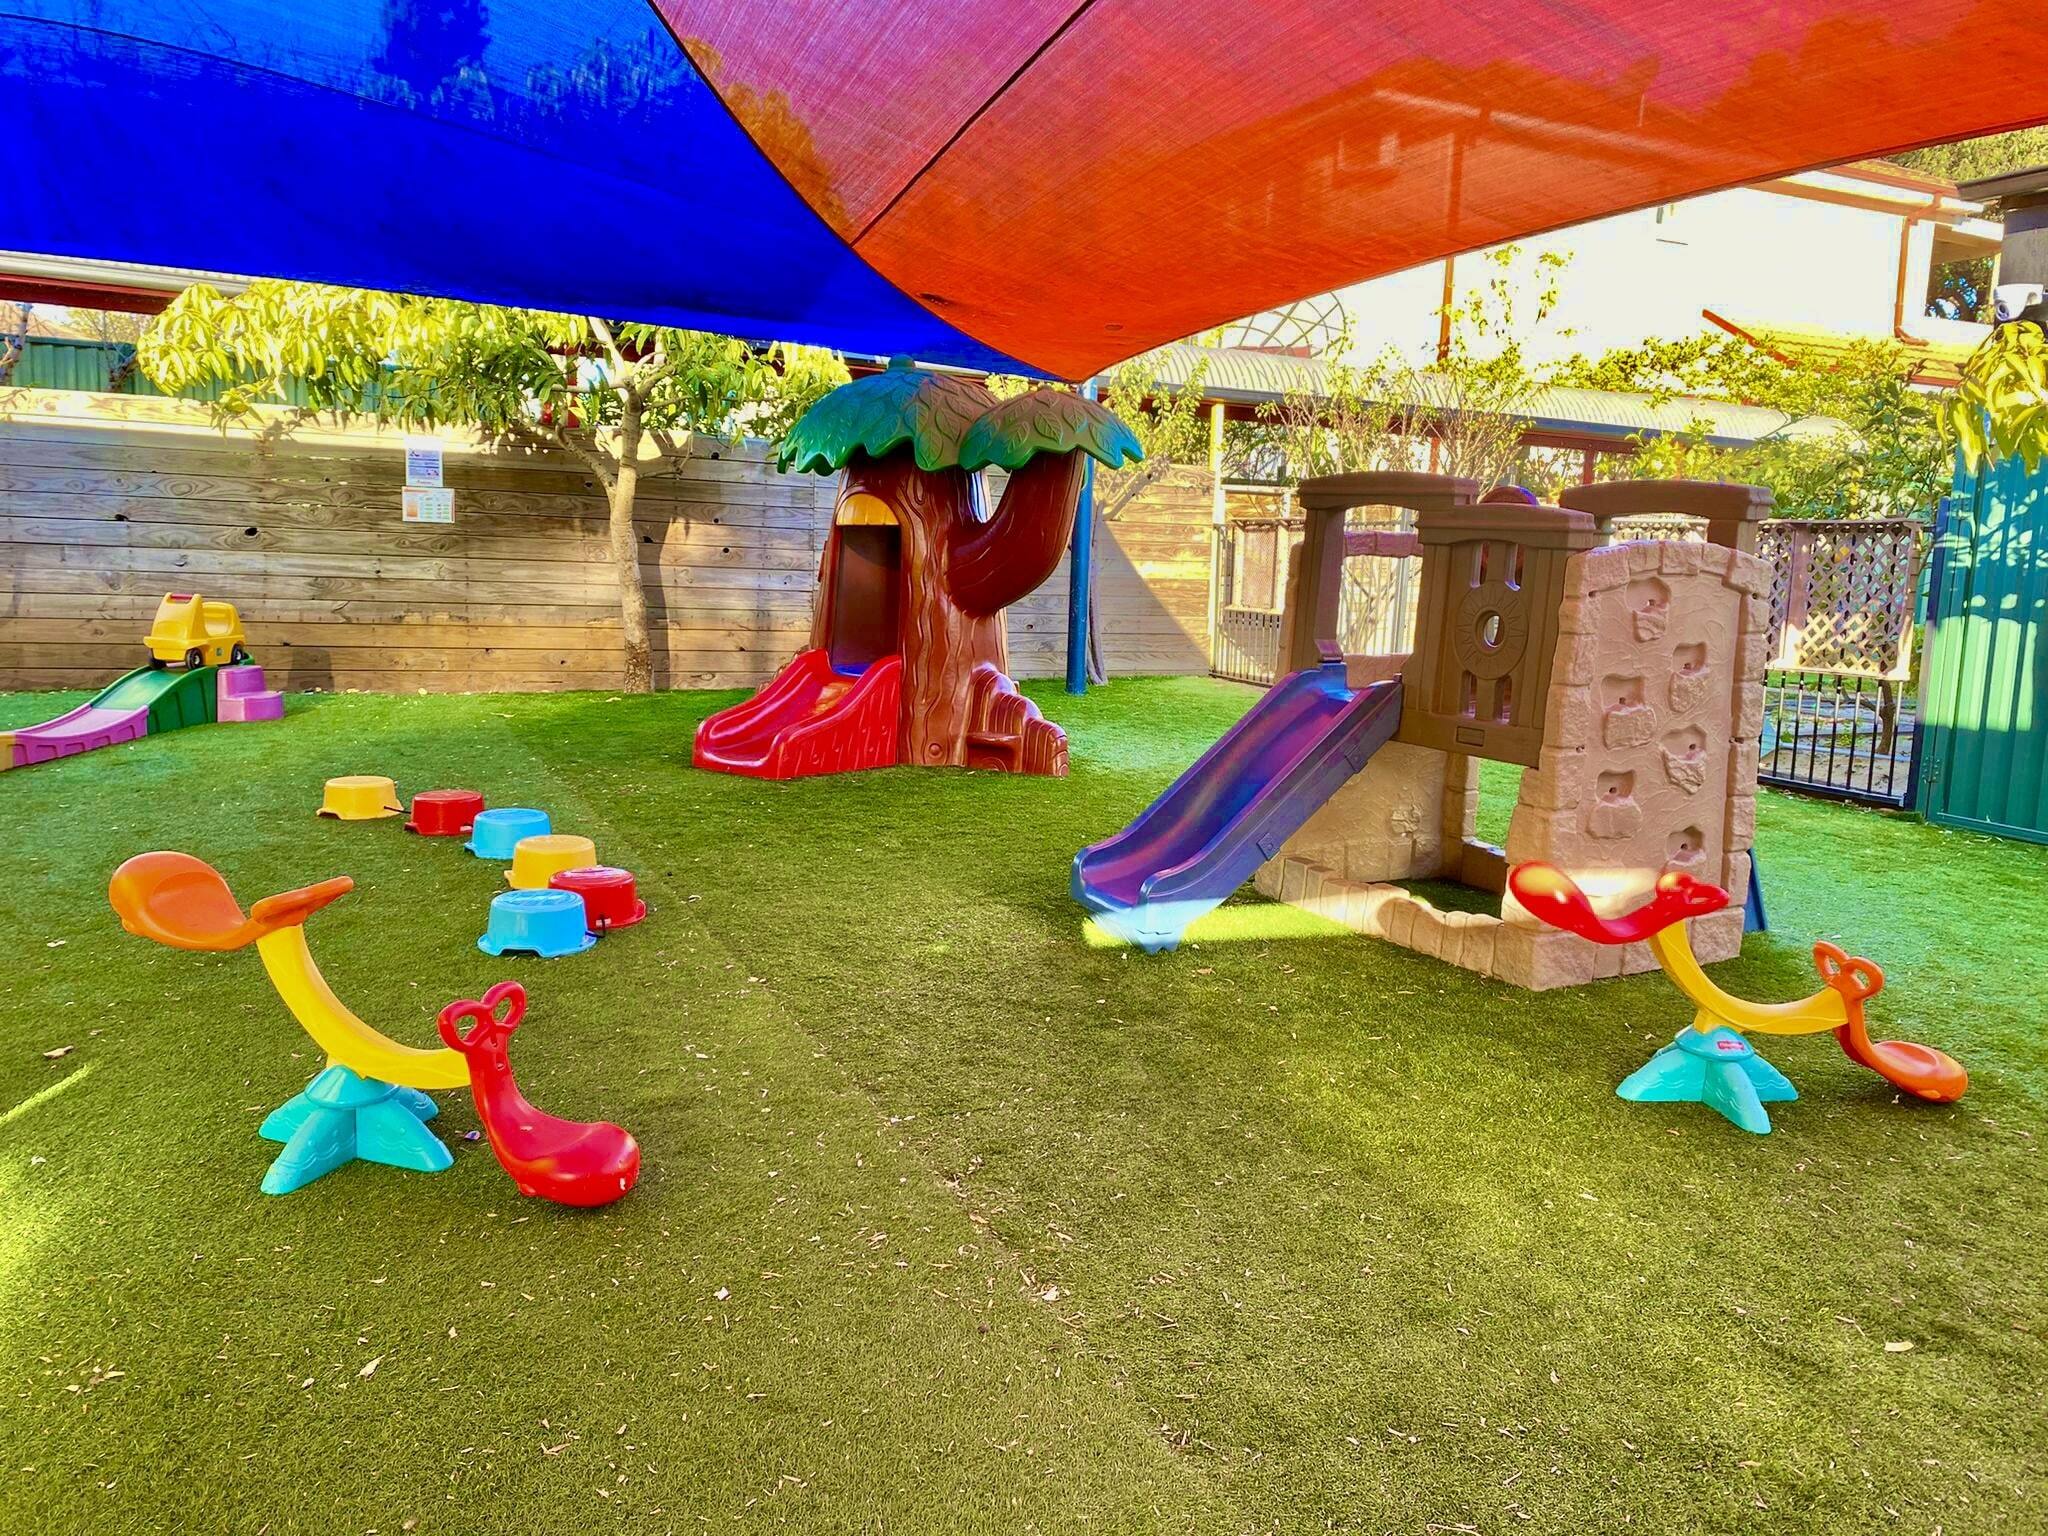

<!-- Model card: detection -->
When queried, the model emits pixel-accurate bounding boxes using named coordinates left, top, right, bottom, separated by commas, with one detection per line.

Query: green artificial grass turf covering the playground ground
left=0, top=680, right=2048, bottom=1534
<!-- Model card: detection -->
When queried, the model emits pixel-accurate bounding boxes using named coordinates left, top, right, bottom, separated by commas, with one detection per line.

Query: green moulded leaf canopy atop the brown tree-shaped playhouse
left=776, top=358, right=1145, bottom=475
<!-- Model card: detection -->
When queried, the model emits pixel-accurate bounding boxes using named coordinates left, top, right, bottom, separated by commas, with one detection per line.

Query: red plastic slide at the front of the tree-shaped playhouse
left=690, top=647, right=903, bottom=778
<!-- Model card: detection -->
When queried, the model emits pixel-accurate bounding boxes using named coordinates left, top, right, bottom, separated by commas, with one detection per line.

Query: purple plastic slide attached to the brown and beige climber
left=1073, top=662, right=1401, bottom=952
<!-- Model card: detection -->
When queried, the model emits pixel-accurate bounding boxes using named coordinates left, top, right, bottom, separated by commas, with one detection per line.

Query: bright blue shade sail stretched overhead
left=0, top=0, right=1028, bottom=371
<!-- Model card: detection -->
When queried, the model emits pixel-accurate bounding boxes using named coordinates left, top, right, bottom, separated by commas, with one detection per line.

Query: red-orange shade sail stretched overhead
left=657, top=0, right=2048, bottom=377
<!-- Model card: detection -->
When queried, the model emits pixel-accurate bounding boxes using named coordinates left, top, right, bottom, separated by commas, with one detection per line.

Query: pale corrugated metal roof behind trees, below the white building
left=1153, top=342, right=1843, bottom=449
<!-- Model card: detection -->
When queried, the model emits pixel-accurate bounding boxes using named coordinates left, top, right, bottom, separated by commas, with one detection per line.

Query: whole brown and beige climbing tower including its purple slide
left=1071, top=473, right=1769, bottom=987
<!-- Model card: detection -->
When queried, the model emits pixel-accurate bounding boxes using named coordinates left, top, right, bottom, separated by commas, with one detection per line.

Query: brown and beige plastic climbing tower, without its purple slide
left=1257, top=475, right=1769, bottom=989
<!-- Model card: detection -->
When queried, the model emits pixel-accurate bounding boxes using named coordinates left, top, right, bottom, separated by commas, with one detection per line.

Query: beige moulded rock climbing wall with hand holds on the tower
left=1495, top=543, right=1769, bottom=987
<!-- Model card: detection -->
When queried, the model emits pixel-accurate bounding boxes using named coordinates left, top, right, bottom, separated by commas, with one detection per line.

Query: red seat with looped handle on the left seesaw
left=438, top=987, right=639, bottom=1206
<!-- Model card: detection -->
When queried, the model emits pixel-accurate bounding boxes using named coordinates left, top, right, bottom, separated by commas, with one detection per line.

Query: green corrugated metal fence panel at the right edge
left=1919, top=461, right=2048, bottom=842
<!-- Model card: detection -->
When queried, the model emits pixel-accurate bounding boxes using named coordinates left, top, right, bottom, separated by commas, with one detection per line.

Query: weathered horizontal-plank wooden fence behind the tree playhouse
left=0, top=389, right=1210, bottom=692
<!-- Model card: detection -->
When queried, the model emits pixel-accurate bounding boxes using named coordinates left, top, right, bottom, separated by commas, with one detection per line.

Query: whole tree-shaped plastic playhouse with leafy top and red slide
left=692, top=360, right=1143, bottom=778
